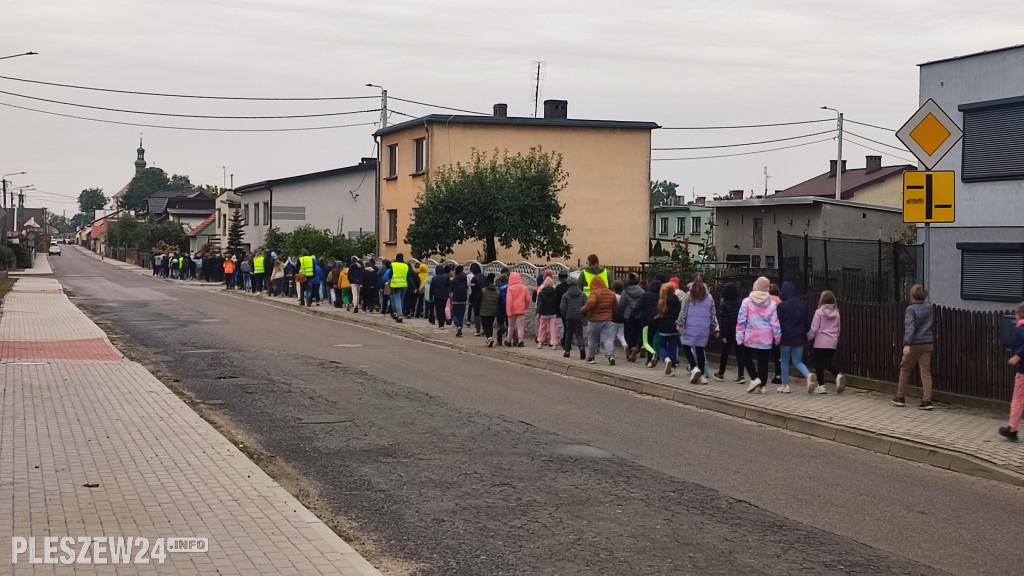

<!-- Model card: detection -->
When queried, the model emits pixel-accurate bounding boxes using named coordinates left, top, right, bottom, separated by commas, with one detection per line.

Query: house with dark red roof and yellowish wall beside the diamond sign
left=774, top=156, right=914, bottom=209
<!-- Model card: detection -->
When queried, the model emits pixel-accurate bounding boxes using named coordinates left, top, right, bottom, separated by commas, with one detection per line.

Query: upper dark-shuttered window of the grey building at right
left=959, top=97, right=1024, bottom=181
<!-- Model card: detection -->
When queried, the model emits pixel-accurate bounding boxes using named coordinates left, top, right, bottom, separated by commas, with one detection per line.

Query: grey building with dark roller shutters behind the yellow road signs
left=918, top=45, right=1024, bottom=311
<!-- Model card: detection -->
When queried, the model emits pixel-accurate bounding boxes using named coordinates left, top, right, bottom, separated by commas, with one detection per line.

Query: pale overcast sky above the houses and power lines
left=0, top=0, right=1024, bottom=217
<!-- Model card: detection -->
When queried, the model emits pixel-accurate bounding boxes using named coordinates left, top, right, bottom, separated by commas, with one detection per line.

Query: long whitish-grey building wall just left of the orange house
left=234, top=158, right=377, bottom=248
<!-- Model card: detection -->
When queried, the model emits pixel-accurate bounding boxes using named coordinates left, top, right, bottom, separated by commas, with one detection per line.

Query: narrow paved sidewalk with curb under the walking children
left=224, top=291, right=1024, bottom=486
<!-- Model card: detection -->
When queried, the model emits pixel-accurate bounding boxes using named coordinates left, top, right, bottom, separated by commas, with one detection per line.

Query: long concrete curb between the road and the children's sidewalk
left=226, top=293, right=1024, bottom=487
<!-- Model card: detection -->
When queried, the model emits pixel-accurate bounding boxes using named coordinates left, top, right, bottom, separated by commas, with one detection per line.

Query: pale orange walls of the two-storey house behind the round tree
left=380, top=124, right=650, bottom=265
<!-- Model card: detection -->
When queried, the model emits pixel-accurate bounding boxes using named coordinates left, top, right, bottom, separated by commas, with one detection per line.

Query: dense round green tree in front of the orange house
left=406, top=147, right=572, bottom=261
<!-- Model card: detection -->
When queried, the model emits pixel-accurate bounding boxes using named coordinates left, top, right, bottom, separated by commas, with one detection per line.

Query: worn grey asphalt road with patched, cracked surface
left=50, top=247, right=1024, bottom=576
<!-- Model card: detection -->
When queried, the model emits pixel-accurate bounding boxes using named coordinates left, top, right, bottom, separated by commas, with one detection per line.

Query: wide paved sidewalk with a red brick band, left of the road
left=0, top=277, right=379, bottom=576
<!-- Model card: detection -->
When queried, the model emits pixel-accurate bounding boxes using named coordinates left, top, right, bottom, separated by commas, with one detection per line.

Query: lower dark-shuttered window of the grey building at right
left=956, top=242, right=1024, bottom=302
